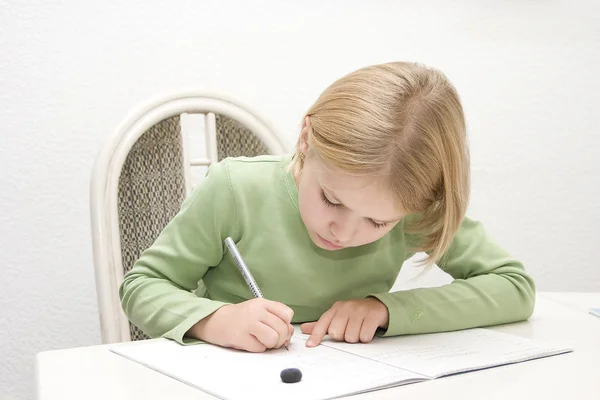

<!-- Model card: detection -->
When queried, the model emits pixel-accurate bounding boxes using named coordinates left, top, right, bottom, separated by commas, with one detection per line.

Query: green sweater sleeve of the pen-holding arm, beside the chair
left=119, top=162, right=237, bottom=344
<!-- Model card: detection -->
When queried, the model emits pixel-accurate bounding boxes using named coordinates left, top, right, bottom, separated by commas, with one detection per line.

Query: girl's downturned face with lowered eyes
left=295, top=120, right=406, bottom=250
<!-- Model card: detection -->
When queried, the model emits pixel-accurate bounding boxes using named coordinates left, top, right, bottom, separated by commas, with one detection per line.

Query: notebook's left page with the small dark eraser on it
left=111, top=337, right=426, bottom=400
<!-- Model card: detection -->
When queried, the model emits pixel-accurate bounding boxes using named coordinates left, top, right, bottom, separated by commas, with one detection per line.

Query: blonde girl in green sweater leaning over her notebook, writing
left=120, top=62, right=535, bottom=352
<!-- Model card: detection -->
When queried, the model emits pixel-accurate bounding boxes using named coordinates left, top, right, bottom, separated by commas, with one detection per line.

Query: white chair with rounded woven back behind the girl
left=90, top=93, right=289, bottom=343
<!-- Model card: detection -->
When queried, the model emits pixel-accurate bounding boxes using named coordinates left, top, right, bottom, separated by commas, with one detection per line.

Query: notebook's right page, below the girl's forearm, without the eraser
left=324, top=329, right=572, bottom=378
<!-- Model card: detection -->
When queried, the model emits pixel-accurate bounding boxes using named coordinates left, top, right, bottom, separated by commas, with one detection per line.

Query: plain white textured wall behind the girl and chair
left=0, top=0, right=600, bottom=400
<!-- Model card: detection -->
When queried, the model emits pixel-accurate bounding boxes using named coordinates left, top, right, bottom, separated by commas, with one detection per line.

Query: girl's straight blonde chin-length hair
left=290, top=62, right=470, bottom=265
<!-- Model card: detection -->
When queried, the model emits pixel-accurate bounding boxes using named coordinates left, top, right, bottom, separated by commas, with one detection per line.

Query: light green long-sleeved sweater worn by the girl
left=119, top=156, right=535, bottom=343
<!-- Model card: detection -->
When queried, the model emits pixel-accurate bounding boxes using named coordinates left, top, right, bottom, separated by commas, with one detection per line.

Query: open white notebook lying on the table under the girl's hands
left=111, top=329, right=572, bottom=400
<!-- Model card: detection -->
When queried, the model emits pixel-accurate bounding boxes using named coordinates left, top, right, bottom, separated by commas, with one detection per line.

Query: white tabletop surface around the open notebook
left=37, top=293, right=600, bottom=400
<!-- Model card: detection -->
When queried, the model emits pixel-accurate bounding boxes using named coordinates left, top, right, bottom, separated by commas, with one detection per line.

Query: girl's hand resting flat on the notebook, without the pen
left=300, top=297, right=389, bottom=347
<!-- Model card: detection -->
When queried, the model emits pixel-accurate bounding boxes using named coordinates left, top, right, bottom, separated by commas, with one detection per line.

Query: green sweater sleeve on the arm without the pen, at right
left=371, top=218, right=535, bottom=336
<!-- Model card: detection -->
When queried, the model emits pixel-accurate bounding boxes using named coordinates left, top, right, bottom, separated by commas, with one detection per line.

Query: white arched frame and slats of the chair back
left=90, top=92, right=289, bottom=343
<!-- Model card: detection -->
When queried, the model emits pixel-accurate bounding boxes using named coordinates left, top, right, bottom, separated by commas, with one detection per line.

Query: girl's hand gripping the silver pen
left=188, top=298, right=294, bottom=353
